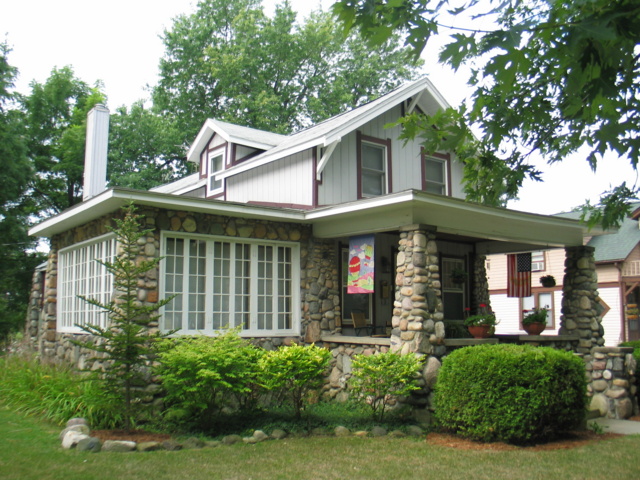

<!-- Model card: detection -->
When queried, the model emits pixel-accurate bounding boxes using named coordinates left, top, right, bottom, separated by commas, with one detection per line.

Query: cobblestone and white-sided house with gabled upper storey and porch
left=30, top=78, right=583, bottom=356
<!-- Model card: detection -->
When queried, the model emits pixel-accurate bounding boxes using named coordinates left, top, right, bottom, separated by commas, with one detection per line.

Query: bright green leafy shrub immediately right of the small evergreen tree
left=157, top=329, right=263, bottom=429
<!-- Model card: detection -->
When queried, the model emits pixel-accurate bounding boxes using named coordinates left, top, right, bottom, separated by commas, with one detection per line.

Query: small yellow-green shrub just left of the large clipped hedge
left=349, top=352, right=422, bottom=421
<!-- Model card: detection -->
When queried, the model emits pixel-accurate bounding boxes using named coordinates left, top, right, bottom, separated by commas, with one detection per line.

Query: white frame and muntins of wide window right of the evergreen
left=160, top=232, right=300, bottom=337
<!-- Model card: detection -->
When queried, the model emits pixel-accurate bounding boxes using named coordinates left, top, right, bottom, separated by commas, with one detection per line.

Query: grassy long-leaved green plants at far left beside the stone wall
left=0, top=355, right=123, bottom=429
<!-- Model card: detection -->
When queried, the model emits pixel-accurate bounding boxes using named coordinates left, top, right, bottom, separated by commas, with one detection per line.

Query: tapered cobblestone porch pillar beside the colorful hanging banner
left=391, top=225, right=444, bottom=355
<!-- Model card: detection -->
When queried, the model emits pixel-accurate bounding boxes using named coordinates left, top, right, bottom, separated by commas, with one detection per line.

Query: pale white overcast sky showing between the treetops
left=0, top=0, right=636, bottom=214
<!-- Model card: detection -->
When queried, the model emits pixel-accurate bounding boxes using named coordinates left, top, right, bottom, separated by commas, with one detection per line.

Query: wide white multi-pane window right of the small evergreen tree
left=161, top=234, right=299, bottom=336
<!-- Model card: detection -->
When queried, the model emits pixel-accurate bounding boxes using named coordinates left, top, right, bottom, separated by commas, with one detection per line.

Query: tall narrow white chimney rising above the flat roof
left=82, top=104, right=109, bottom=200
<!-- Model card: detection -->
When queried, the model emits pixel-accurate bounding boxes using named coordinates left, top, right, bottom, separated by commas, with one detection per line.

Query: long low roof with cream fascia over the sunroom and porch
left=29, top=188, right=594, bottom=254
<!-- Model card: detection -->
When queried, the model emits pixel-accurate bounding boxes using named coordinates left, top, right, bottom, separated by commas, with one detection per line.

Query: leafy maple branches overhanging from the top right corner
left=334, top=0, right=640, bottom=227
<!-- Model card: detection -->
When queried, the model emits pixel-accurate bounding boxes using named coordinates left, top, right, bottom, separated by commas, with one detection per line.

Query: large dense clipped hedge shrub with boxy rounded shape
left=435, top=345, right=586, bottom=444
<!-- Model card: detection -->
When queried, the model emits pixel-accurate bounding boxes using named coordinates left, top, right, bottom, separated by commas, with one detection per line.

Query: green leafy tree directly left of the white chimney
left=23, top=67, right=105, bottom=215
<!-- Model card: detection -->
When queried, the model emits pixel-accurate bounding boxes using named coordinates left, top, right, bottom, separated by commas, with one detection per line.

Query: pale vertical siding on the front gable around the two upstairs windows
left=318, top=106, right=464, bottom=205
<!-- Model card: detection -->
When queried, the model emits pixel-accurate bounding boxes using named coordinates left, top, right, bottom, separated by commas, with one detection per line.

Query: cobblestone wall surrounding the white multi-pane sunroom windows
left=28, top=207, right=341, bottom=369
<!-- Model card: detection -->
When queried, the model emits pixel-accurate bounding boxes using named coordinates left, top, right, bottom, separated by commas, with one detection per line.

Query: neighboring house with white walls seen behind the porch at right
left=486, top=203, right=640, bottom=347
